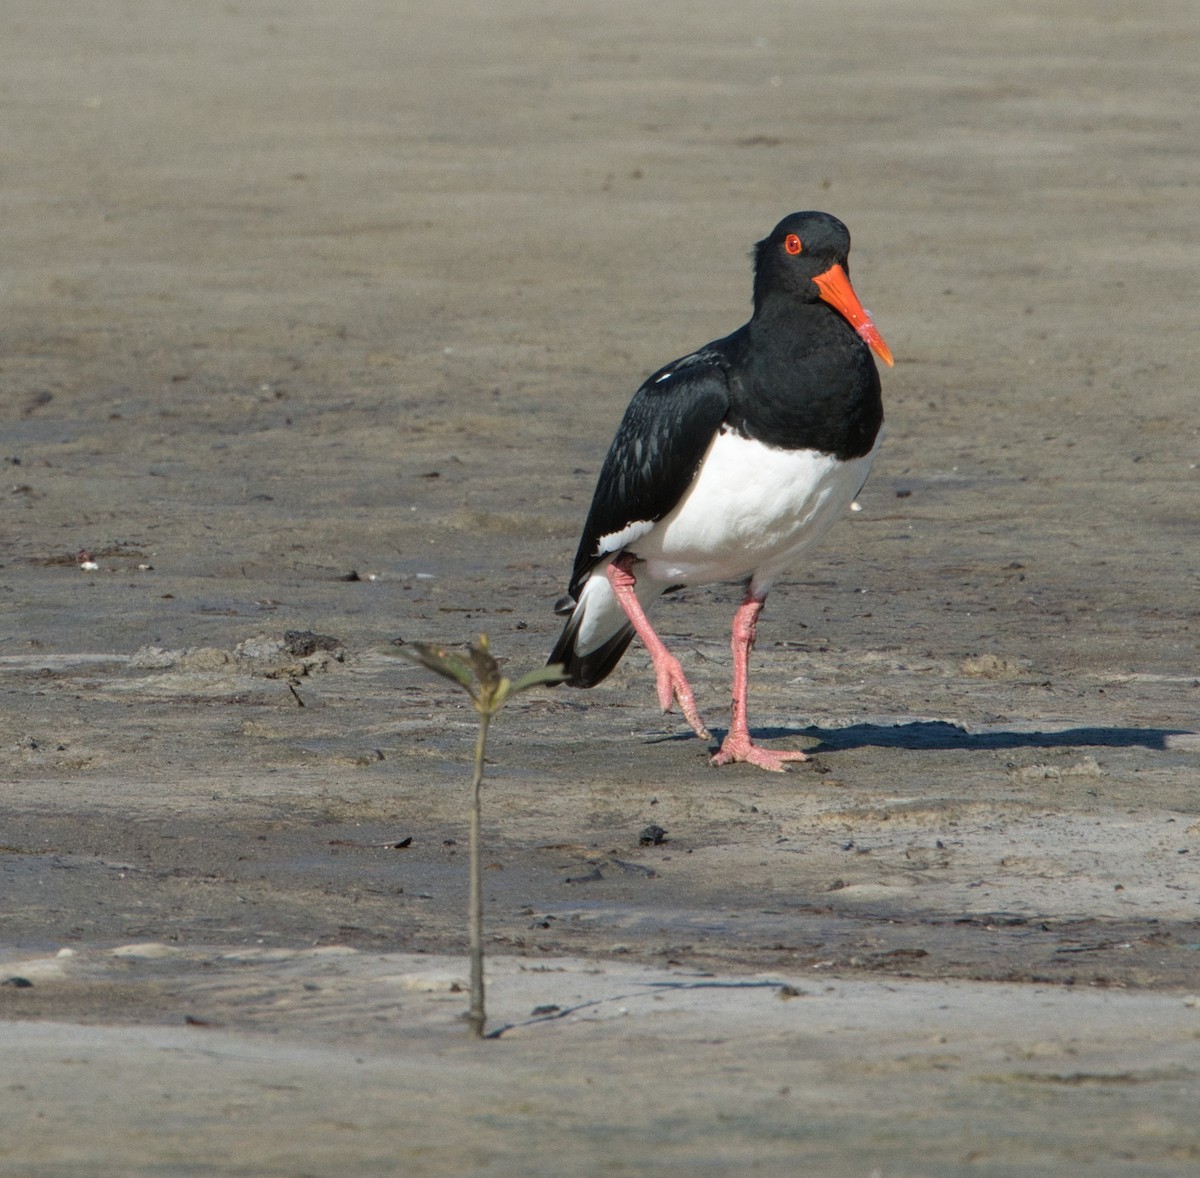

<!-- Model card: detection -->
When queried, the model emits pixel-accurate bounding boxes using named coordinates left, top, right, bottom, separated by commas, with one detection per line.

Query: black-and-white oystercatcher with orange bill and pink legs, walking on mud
left=548, top=211, right=893, bottom=771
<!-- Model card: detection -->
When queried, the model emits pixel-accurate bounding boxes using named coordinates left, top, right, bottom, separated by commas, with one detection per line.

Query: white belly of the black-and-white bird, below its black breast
left=629, top=431, right=875, bottom=591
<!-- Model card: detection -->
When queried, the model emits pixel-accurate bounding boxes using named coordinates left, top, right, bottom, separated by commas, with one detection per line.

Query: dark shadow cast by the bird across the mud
left=652, top=720, right=1193, bottom=753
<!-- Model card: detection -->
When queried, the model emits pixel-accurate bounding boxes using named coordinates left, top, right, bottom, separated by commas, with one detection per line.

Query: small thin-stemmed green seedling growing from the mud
left=388, top=635, right=563, bottom=1039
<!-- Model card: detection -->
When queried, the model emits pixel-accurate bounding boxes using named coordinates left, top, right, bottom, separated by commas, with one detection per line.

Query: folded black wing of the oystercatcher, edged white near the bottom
left=563, top=341, right=730, bottom=605
